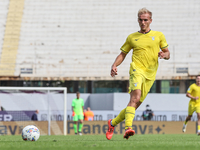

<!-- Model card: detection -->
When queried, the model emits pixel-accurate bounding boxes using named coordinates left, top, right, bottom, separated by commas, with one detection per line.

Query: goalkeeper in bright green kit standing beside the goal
left=72, top=92, right=84, bottom=135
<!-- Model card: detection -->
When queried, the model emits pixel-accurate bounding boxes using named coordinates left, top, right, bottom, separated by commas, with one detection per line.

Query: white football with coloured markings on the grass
left=22, top=125, right=40, bottom=141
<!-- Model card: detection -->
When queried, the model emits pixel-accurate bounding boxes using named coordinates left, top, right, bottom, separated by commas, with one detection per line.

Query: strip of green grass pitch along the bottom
left=0, top=134, right=200, bottom=150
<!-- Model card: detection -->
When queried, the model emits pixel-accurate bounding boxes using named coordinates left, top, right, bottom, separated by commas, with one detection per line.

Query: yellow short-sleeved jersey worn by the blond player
left=121, top=30, right=168, bottom=80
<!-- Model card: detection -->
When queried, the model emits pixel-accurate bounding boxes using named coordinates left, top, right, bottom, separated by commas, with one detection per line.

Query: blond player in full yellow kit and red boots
left=106, top=8, right=170, bottom=140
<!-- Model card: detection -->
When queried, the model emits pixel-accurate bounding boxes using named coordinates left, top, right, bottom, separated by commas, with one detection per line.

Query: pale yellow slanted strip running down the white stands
left=0, top=0, right=24, bottom=76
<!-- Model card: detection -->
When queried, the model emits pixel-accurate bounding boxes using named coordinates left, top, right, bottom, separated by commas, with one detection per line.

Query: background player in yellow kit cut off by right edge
left=182, top=75, right=200, bottom=135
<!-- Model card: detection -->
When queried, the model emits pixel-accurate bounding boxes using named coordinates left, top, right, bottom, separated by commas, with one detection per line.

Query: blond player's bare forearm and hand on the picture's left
left=110, top=52, right=126, bottom=77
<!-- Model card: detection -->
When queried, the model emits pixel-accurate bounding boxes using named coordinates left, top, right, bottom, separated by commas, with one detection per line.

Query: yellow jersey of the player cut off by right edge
left=187, top=83, right=200, bottom=105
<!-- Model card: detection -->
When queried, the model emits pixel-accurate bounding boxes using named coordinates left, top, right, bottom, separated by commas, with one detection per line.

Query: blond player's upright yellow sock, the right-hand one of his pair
left=125, top=106, right=135, bottom=130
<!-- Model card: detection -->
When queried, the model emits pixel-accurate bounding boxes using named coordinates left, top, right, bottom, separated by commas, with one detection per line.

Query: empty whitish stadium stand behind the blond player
left=0, top=0, right=200, bottom=80
